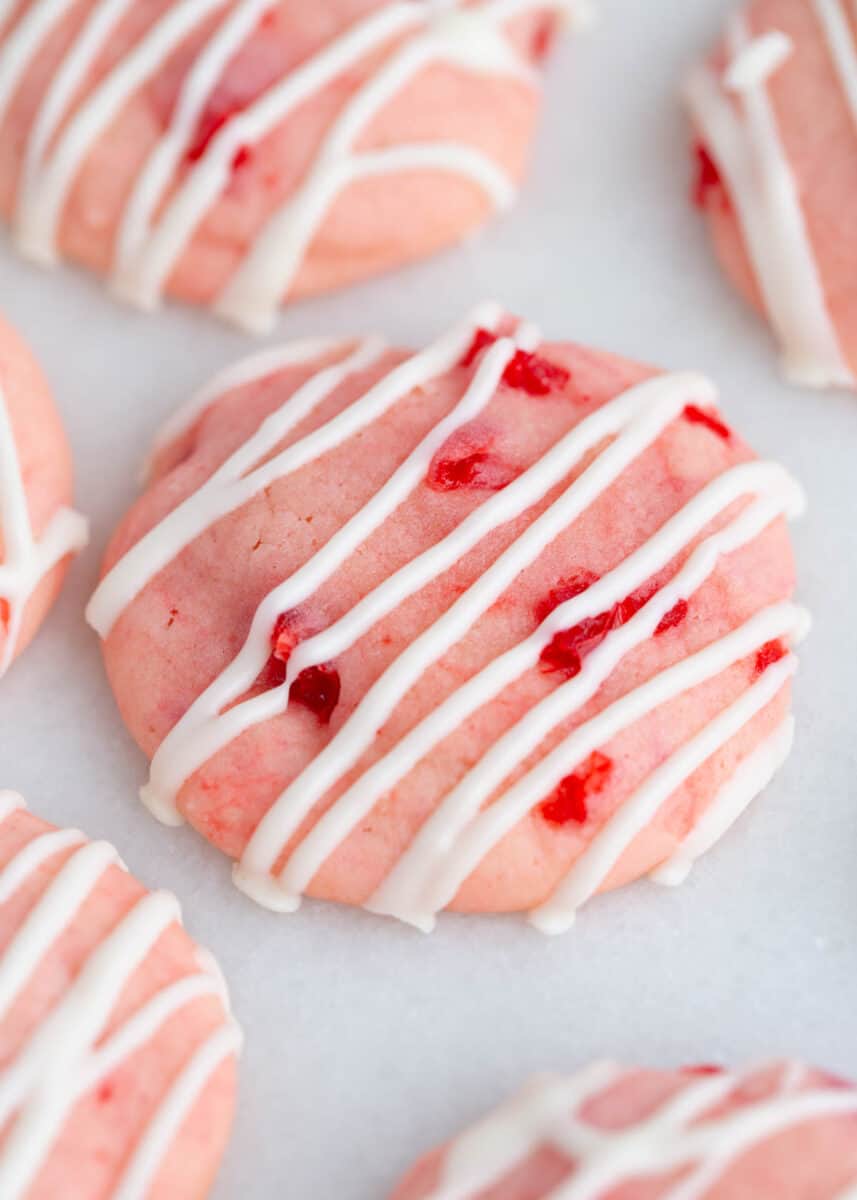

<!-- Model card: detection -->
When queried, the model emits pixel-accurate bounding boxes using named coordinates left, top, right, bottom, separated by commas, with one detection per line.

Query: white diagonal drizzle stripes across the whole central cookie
left=88, top=305, right=808, bottom=932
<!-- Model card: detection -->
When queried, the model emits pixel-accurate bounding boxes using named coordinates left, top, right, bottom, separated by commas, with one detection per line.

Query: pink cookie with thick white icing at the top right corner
left=685, top=0, right=857, bottom=388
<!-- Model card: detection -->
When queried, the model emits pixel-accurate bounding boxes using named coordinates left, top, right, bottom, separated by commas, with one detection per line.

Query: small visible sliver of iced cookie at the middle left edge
left=0, top=320, right=86, bottom=676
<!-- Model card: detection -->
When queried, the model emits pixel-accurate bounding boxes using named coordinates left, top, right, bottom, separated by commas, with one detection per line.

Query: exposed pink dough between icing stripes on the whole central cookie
left=93, top=312, right=795, bottom=926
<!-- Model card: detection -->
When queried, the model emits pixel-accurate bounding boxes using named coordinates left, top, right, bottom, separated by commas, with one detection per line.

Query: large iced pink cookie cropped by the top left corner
left=0, top=0, right=577, bottom=329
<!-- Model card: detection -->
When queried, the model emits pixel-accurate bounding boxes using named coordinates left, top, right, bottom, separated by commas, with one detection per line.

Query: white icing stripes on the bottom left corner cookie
left=0, top=792, right=240, bottom=1200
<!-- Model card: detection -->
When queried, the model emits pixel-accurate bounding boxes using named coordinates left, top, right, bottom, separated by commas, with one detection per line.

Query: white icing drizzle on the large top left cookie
left=0, top=0, right=573, bottom=330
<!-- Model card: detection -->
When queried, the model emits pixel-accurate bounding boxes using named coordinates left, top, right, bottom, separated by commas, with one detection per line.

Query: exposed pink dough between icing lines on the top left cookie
left=0, top=0, right=573, bottom=326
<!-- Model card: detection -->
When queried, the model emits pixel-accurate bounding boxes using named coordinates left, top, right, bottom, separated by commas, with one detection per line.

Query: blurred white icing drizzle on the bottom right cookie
left=426, top=1063, right=857, bottom=1200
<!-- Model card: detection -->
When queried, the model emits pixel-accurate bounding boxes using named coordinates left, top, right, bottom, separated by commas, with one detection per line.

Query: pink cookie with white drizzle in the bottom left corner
left=0, top=792, right=240, bottom=1200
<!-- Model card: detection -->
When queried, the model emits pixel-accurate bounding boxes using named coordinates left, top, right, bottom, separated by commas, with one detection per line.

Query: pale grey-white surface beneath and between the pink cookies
left=0, top=0, right=857, bottom=1200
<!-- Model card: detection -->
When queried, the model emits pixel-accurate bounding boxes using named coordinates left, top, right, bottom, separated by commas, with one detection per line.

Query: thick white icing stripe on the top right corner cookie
left=685, top=16, right=855, bottom=388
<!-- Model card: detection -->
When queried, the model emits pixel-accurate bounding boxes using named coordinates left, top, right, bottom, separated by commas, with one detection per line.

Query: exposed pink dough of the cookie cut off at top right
left=695, top=0, right=857, bottom=385
